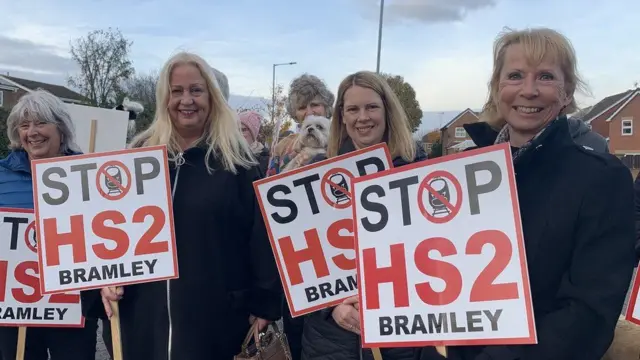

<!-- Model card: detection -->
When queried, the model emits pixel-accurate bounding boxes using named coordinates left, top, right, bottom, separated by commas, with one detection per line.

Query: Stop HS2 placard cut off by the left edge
left=0, top=208, right=84, bottom=327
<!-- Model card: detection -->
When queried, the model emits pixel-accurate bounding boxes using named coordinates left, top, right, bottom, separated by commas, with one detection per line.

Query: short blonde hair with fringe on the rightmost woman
left=480, top=28, right=588, bottom=129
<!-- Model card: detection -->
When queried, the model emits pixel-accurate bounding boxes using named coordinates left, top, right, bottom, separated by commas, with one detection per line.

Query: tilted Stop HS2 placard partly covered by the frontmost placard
left=254, top=144, right=391, bottom=316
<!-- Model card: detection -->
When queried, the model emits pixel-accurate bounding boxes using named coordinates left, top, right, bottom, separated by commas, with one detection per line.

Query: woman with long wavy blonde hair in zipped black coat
left=81, top=52, right=282, bottom=360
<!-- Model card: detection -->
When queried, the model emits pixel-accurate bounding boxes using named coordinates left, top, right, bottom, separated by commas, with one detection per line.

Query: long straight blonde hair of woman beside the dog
left=327, top=71, right=416, bottom=162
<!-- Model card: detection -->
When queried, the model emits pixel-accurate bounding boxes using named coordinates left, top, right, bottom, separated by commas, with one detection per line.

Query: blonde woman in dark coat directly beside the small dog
left=302, top=71, right=430, bottom=360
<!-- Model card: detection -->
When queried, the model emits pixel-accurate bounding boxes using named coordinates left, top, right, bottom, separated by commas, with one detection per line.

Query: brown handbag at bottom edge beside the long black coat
left=234, top=321, right=292, bottom=360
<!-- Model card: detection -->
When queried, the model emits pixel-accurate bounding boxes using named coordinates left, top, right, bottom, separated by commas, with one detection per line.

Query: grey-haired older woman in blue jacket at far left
left=0, top=90, right=97, bottom=360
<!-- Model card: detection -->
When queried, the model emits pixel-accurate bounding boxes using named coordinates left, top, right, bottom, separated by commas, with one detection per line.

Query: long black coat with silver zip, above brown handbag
left=82, top=147, right=282, bottom=360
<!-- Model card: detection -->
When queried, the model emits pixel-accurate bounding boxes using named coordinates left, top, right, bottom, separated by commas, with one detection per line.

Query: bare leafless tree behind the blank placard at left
left=67, top=28, right=135, bottom=107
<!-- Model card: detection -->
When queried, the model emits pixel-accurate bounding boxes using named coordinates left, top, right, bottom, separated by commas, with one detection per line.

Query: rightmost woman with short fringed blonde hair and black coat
left=416, top=28, right=636, bottom=360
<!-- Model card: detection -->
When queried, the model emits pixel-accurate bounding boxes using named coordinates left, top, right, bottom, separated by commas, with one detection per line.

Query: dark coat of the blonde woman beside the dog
left=302, top=141, right=437, bottom=360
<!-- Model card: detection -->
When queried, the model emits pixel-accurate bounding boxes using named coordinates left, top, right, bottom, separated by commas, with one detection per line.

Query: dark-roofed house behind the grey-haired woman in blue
left=0, top=75, right=88, bottom=109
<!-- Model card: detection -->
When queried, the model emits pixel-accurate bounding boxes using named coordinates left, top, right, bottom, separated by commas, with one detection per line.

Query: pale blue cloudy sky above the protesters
left=0, top=0, right=640, bottom=132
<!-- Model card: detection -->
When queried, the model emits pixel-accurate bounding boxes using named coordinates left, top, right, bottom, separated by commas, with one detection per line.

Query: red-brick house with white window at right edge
left=583, top=89, right=640, bottom=170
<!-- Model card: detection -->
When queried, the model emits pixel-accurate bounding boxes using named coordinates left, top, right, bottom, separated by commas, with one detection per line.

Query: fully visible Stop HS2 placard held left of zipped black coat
left=31, top=146, right=178, bottom=294
